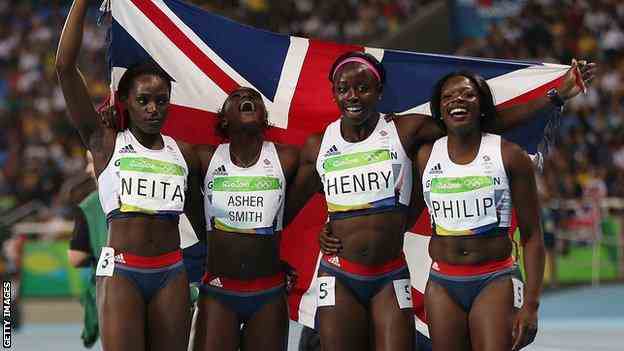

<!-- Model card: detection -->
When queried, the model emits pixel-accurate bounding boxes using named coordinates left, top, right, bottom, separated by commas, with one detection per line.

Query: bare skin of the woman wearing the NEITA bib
left=56, top=0, right=203, bottom=350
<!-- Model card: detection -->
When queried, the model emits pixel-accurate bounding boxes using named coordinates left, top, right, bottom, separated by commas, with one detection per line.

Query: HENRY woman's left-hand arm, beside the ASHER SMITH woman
left=284, top=134, right=321, bottom=227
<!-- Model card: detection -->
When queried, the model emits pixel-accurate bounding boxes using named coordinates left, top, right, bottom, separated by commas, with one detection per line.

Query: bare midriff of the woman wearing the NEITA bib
left=108, top=216, right=180, bottom=257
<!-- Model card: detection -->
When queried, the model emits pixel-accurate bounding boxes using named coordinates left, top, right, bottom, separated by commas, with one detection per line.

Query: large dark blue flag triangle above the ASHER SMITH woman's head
left=165, top=0, right=290, bottom=100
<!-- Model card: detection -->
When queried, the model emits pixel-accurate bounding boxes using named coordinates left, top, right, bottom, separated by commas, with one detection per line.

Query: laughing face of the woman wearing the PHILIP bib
left=440, top=76, right=481, bottom=134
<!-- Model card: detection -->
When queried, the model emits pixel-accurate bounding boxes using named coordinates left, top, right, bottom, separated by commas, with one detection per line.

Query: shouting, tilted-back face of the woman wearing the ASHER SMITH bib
left=221, top=88, right=268, bottom=134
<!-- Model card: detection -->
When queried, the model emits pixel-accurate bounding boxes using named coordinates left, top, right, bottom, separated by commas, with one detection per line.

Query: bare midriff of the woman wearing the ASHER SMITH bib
left=208, top=229, right=282, bottom=280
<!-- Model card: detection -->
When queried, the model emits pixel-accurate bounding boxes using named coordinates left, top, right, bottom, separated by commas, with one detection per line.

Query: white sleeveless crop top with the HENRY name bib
left=316, top=115, right=412, bottom=219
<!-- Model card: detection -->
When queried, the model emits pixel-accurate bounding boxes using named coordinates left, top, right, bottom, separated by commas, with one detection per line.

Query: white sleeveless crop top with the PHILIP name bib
left=422, top=133, right=512, bottom=236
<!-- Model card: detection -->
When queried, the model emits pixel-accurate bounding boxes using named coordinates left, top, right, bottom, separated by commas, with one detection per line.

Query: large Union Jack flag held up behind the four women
left=108, top=0, right=568, bottom=335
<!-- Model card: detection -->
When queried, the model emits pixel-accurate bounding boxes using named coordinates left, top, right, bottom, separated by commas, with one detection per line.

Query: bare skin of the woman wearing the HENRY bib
left=298, top=59, right=595, bottom=350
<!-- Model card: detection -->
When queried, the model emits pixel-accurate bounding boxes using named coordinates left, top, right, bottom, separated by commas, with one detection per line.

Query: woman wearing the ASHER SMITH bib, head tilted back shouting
left=193, top=88, right=299, bottom=351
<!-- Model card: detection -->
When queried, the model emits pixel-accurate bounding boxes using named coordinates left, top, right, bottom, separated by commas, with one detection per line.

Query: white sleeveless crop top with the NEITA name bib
left=98, top=129, right=188, bottom=219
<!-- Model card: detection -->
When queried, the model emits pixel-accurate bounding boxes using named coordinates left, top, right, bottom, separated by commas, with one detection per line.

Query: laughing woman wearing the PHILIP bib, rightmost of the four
left=416, top=72, right=545, bottom=351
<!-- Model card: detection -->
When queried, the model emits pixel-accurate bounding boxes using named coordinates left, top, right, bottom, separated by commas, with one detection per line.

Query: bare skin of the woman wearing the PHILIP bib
left=417, top=76, right=545, bottom=350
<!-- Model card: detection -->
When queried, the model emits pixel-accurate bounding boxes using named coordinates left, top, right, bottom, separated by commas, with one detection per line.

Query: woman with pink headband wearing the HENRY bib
left=285, top=52, right=593, bottom=350
